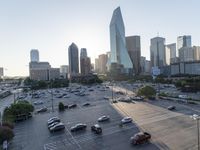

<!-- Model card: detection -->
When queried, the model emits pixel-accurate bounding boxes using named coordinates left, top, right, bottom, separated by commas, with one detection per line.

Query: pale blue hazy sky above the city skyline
left=0, top=0, right=200, bottom=76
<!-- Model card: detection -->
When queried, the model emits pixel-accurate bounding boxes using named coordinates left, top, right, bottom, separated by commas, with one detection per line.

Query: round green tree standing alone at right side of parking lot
left=138, top=86, right=156, bottom=98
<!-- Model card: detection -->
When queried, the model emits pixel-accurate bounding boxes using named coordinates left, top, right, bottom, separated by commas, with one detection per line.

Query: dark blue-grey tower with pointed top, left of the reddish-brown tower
left=68, top=43, right=79, bottom=76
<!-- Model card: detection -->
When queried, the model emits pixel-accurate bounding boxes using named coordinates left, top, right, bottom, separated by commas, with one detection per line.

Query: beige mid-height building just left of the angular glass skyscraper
left=98, top=54, right=108, bottom=74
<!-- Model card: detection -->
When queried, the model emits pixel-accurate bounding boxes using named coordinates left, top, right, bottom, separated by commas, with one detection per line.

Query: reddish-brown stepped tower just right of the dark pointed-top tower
left=80, top=48, right=91, bottom=75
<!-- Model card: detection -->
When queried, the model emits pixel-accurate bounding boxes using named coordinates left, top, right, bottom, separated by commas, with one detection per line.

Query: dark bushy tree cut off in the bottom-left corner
left=0, top=126, right=14, bottom=144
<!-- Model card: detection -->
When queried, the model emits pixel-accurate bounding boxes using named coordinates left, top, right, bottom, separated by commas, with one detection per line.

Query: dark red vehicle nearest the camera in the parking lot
left=130, top=132, right=151, bottom=145
